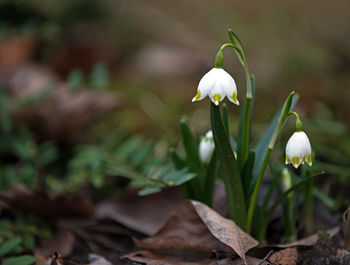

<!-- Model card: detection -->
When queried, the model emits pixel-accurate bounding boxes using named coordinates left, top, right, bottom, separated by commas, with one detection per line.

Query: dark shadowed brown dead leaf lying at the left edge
left=0, top=184, right=95, bottom=219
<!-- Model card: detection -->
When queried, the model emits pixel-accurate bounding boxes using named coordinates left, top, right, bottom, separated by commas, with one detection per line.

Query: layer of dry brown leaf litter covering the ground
left=0, top=185, right=348, bottom=265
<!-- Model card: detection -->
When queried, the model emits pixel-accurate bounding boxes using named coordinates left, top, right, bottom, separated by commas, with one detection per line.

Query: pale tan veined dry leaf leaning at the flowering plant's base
left=191, top=201, right=259, bottom=259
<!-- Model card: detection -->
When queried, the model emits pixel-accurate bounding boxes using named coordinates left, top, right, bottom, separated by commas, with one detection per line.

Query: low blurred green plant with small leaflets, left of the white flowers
left=47, top=130, right=195, bottom=195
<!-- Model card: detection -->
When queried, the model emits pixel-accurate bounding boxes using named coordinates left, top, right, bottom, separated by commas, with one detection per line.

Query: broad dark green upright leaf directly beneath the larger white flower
left=210, top=103, right=246, bottom=229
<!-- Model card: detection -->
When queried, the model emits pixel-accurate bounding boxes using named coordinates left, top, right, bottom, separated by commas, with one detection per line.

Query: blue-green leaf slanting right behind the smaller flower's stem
left=252, top=95, right=298, bottom=187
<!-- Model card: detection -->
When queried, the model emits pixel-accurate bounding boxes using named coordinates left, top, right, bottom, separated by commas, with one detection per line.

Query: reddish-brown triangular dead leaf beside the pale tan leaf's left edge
left=134, top=201, right=232, bottom=253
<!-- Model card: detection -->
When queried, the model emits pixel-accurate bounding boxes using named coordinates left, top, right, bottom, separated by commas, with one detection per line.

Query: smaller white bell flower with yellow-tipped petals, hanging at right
left=286, top=131, right=312, bottom=168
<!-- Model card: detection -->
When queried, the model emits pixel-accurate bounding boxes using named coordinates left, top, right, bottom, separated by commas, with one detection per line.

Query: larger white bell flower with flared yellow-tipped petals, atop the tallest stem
left=192, top=68, right=239, bottom=105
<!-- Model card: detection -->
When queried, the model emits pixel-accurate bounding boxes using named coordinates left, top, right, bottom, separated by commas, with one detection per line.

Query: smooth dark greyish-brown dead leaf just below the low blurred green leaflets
left=96, top=188, right=181, bottom=235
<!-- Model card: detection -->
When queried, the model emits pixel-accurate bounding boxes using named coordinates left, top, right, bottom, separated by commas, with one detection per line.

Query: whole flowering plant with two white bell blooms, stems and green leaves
left=173, top=30, right=317, bottom=241
